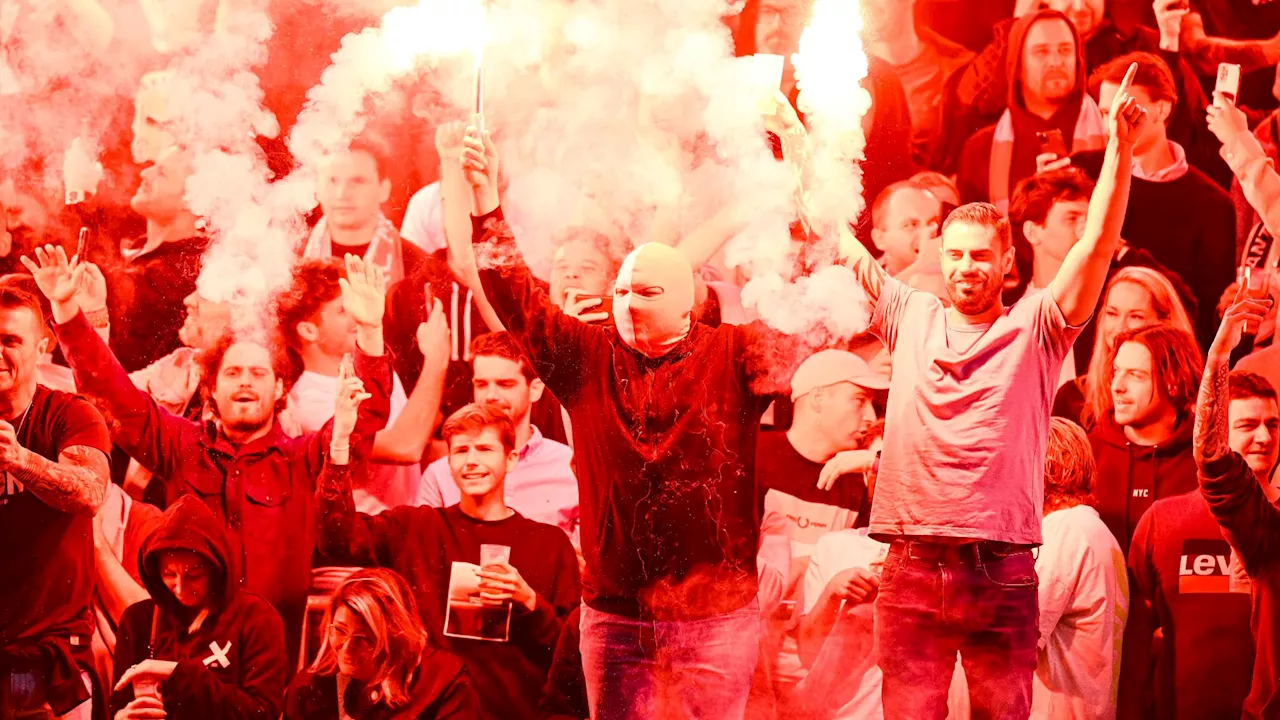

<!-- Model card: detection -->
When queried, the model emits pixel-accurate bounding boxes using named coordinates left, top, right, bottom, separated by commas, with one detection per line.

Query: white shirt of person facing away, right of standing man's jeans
left=1032, top=505, right=1129, bottom=720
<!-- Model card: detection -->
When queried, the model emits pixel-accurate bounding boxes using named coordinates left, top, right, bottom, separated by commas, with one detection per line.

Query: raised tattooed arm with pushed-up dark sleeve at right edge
left=1192, top=288, right=1280, bottom=575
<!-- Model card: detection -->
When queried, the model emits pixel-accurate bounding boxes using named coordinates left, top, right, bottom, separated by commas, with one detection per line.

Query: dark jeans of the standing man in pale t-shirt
left=876, top=539, right=1039, bottom=720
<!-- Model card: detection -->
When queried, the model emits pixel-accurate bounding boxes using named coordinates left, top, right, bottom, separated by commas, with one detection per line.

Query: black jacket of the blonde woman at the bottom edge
left=284, top=647, right=480, bottom=720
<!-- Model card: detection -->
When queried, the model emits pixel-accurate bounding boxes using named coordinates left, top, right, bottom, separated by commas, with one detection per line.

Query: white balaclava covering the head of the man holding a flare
left=613, top=242, right=694, bottom=357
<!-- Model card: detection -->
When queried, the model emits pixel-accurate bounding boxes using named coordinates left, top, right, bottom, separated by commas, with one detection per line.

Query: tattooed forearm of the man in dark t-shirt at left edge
left=10, top=445, right=111, bottom=514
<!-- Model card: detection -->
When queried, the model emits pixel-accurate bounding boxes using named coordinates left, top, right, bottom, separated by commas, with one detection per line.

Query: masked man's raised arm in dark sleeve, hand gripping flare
left=460, top=114, right=609, bottom=404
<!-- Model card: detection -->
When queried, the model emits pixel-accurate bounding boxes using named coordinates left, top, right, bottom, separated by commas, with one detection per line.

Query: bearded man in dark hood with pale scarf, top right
left=956, top=10, right=1106, bottom=214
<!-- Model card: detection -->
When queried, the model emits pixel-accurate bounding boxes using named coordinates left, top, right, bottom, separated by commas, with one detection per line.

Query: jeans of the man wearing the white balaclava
left=581, top=600, right=760, bottom=720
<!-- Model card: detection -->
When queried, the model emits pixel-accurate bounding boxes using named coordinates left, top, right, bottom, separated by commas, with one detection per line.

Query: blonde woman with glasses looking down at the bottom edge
left=284, top=569, right=479, bottom=720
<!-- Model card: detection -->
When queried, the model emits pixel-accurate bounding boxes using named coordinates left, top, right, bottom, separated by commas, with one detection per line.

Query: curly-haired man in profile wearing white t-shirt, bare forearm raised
left=276, top=258, right=448, bottom=515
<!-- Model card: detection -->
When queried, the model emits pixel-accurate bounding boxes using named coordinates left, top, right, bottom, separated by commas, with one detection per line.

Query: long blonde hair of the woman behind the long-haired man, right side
left=1080, top=266, right=1198, bottom=429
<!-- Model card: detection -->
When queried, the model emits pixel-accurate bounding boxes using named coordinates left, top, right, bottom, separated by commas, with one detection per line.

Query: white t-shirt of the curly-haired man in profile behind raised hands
left=289, top=370, right=421, bottom=515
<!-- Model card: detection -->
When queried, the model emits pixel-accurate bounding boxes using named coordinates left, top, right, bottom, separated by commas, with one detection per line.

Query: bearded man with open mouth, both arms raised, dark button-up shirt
left=28, top=249, right=392, bottom=653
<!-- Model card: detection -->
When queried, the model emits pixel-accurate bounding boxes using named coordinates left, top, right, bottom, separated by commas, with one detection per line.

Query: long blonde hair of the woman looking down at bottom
left=311, top=568, right=426, bottom=707
